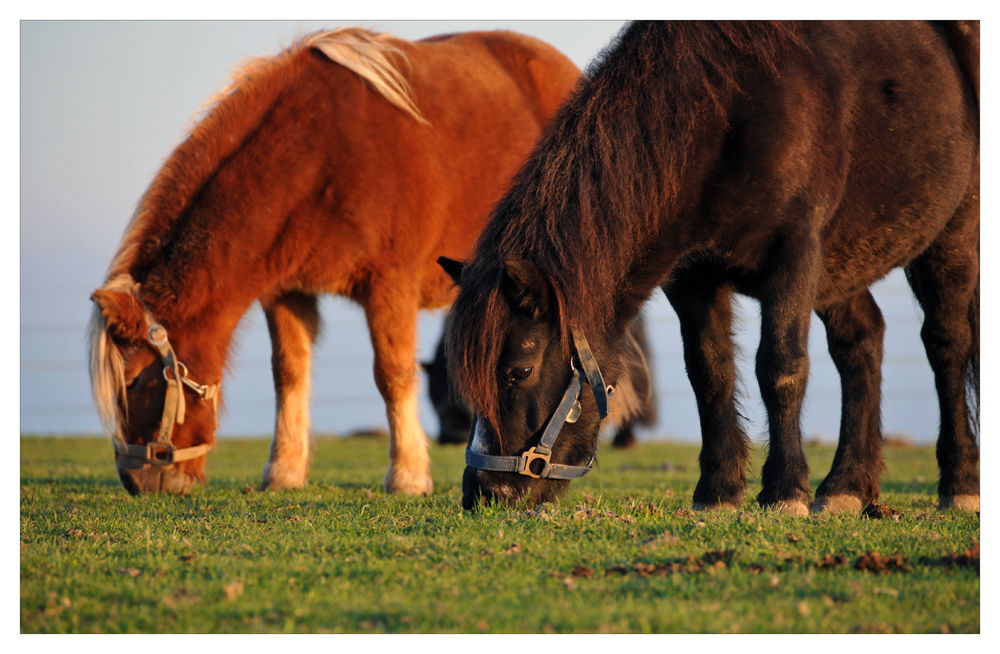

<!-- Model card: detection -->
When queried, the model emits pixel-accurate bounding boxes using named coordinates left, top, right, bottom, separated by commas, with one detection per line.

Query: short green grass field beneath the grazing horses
left=21, top=438, right=980, bottom=633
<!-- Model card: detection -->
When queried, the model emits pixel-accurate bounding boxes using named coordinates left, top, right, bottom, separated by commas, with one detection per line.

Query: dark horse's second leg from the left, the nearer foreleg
left=756, top=235, right=821, bottom=516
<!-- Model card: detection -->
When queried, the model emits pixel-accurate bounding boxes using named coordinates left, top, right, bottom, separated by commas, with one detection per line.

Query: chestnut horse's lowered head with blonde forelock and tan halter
left=88, top=275, right=219, bottom=495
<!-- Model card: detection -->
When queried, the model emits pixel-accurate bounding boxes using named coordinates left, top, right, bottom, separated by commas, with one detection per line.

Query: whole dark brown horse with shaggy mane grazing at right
left=440, top=21, right=979, bottom=515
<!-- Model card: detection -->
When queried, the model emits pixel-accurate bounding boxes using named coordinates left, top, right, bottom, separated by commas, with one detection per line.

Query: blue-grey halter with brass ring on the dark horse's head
left=465, top=328, right=615, bottom=479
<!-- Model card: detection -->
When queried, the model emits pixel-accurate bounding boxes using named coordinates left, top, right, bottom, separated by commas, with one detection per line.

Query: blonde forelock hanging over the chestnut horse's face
left=87, top=275, right=138, bottom=440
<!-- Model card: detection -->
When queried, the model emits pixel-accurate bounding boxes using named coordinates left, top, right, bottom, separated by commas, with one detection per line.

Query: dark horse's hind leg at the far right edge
left=906, top=217, right=979, bottom=511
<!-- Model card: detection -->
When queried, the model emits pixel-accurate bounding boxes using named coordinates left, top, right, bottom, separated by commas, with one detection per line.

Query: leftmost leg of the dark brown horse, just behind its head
left=664, top=272, right=750, bottom=509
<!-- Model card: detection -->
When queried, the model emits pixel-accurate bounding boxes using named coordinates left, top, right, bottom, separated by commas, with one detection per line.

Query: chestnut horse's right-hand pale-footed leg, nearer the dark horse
left=365, top=280, right=434, bottom=495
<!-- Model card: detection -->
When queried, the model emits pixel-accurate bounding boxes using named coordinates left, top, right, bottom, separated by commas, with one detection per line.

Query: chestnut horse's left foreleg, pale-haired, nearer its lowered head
left=261, top=293, right=320, bottom=490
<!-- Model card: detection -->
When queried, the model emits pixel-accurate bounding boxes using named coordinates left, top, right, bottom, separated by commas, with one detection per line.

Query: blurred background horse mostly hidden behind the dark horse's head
left=420, top=317, right=656, bottom=449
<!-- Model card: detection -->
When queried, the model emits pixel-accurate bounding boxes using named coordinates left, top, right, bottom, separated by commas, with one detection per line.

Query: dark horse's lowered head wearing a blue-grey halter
left=439, top=257, right=638, bottom=509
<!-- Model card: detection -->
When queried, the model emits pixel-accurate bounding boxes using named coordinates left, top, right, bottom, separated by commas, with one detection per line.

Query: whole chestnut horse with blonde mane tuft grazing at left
left=89, top=29, right=580, bottom=494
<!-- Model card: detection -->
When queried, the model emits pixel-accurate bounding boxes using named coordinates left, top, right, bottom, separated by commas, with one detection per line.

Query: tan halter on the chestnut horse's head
left=111, top=310, right=219, bottom=466
